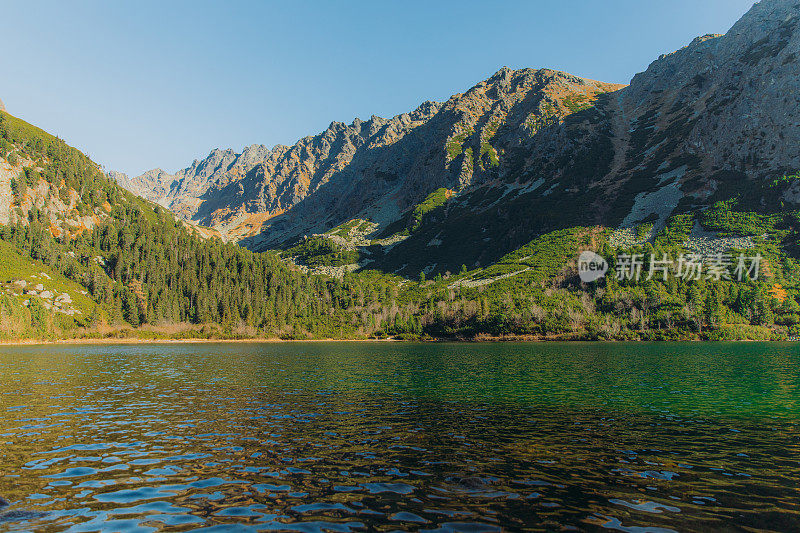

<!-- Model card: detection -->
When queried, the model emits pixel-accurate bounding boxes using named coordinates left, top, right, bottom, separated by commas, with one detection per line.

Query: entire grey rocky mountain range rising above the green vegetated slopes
left=122, top=0, right=800, bottom=273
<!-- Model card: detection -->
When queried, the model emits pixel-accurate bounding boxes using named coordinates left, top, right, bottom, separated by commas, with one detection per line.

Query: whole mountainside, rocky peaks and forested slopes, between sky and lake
left=0, top=0, right=800, bottom=340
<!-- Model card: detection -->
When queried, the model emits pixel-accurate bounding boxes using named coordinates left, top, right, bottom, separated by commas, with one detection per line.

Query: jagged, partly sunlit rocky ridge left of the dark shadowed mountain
left=126, top=68, right=620, bottom=245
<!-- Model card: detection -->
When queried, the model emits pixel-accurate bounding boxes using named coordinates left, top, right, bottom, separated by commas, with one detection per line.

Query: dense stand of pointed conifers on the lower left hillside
left=3, top=206, right=406, bottom=337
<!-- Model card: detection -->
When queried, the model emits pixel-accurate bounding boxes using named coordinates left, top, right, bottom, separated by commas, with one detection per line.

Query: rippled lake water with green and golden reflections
left=0, top=343, right=800, bottom=532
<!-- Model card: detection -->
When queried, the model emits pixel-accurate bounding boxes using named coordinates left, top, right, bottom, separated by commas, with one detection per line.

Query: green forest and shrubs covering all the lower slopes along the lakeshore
left=0, top=105, right=800, bottom=339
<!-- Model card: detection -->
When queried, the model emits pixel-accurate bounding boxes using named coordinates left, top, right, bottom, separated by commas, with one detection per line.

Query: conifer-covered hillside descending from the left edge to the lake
left=0, top=112, right=400, bottom=338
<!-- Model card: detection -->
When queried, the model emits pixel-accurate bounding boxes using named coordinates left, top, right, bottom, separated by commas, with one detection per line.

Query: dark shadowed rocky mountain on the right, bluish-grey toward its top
left=384, top=0, right=800, bottom=271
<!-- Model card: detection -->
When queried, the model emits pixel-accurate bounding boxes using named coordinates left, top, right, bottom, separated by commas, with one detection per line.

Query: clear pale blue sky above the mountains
left=0, top=0, right=753, bottom=175
